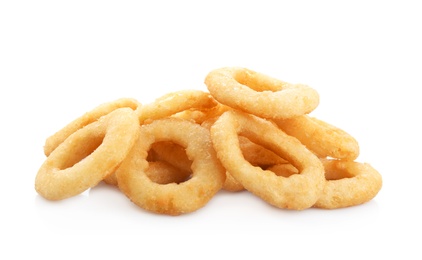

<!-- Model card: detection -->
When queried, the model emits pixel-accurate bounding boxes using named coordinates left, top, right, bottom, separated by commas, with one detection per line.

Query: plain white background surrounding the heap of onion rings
left=0, top=0, right=422, bottom=259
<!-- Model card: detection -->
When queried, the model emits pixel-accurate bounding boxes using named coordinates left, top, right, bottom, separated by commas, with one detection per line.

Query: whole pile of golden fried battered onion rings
left=35, top=67, right=382, bottom=216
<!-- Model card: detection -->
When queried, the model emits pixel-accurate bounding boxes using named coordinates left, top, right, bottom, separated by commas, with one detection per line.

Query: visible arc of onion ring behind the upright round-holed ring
left=136, top=90, right=218, bottom=124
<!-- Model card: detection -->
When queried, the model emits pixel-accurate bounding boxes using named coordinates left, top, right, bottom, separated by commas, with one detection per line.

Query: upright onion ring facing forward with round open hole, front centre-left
left=116, top=118, right=225, bottom=215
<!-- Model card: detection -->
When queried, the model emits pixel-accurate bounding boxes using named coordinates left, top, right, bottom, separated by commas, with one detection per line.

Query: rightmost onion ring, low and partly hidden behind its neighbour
left=314, top=159, right=382, bottom=209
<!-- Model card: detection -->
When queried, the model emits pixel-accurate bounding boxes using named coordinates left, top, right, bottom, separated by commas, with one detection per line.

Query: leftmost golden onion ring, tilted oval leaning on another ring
left=35, top=108, right=139, bottom=200
